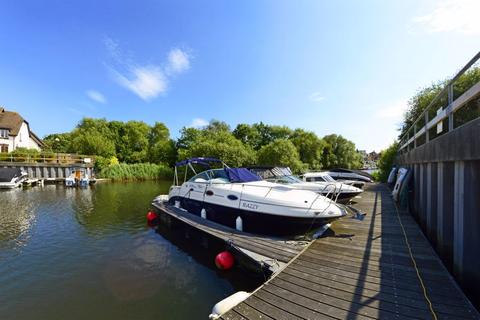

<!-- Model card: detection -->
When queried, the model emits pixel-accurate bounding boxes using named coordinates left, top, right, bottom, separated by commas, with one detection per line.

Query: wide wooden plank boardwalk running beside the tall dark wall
left=221, top=184, right=480, bottom=320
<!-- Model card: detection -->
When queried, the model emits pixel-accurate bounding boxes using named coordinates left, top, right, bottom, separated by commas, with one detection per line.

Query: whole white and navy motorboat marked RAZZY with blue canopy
left=163, top=158, right=346, bottom=235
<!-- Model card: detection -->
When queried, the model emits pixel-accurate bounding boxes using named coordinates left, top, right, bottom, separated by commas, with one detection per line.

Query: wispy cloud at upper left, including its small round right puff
left=104, top=37, right=190, bottom=101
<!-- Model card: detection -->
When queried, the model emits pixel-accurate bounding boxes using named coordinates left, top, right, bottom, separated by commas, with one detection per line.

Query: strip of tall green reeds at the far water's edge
left=98, top=163, right=173, bottom=181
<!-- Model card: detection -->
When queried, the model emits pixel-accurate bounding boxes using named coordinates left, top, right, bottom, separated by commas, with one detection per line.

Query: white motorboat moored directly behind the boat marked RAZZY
left=249, top=166, right=363, bottom=203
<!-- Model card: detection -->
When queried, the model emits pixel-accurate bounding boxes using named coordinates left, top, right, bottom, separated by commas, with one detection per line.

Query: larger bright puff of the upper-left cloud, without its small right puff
left=114, top=66, right=167, bottom=101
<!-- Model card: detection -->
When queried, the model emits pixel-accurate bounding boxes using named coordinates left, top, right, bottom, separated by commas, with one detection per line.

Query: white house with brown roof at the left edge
left=0, top=107, right=43, bottom=152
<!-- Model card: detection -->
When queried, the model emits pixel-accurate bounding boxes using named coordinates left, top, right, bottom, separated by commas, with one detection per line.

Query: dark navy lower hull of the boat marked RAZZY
left=168, top=197, right=339, bottom=236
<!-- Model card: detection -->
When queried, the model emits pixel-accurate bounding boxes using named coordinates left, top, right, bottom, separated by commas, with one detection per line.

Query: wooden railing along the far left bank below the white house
left=0, top=152, right=95, bottom=165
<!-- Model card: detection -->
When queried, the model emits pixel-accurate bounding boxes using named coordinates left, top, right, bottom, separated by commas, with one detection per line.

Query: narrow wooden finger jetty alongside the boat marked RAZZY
left=152, top=200, right=309, bottom=272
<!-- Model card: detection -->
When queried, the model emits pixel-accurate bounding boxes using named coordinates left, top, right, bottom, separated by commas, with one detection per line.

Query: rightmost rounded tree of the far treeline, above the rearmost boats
left=322, top=134, right=362, bottom=169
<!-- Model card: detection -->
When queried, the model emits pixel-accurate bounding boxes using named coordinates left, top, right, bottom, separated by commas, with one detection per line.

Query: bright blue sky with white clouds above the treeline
left=0, top=0, right=480, bottom=151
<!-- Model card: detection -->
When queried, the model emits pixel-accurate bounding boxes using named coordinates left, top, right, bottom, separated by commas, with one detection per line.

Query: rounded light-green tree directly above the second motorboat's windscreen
left=258, top=139, right=304, bottom=172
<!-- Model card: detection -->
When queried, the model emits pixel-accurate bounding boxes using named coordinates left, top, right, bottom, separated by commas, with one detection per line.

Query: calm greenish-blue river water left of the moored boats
left=0, top=182, right=259, bottom=320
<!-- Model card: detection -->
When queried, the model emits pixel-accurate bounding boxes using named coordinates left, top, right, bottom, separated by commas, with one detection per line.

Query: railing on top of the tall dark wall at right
left=399, top=52, right=480, bottom=153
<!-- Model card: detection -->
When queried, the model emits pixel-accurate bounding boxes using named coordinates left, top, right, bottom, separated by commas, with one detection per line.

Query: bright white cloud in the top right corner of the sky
left=413, top=0, right=480, bottom=35
